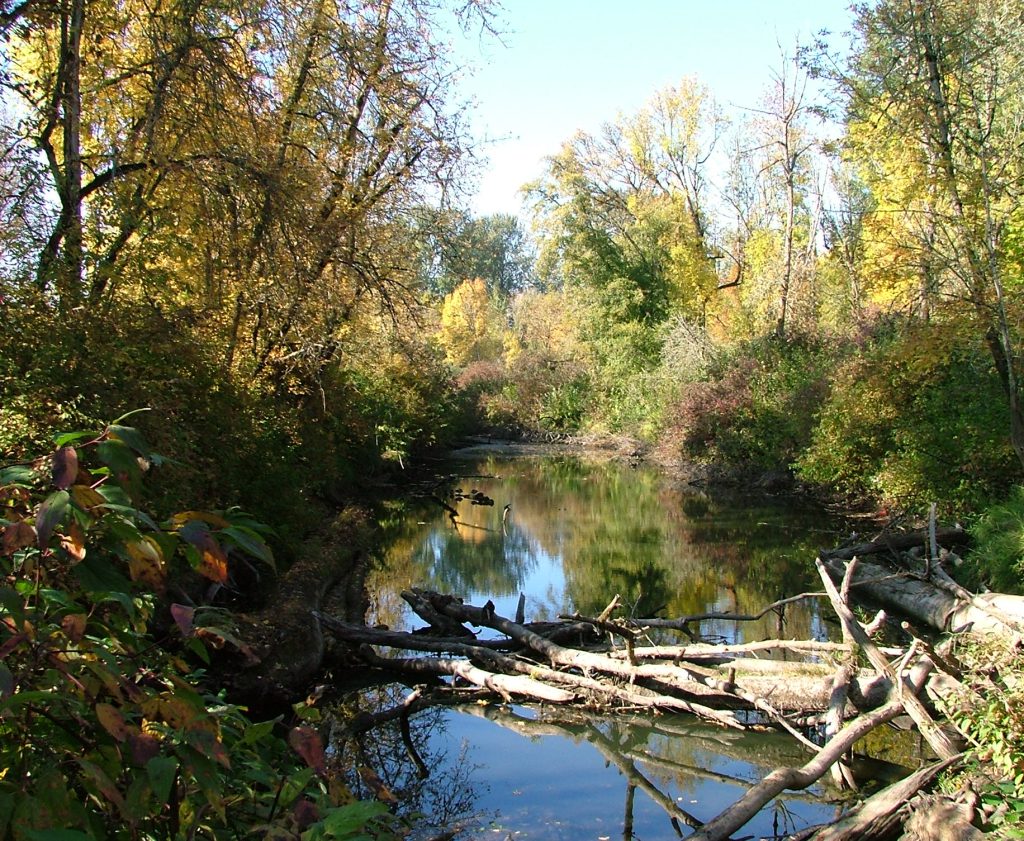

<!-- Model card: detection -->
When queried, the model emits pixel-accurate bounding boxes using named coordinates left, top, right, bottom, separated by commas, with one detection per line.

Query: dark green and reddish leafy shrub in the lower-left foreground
left=0, top=421, right=392, bottom=841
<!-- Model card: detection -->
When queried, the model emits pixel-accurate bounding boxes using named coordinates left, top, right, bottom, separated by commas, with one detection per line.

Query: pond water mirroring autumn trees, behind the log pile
left=371, top=457, right=837, bottom=641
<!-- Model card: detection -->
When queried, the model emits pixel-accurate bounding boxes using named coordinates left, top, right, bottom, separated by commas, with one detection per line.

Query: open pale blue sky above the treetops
left=453, top=0, right=852, bottom=215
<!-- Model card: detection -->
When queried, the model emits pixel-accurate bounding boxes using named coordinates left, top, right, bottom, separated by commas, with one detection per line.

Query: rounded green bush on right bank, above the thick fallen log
left=798, top=322, right=1014, bottom=509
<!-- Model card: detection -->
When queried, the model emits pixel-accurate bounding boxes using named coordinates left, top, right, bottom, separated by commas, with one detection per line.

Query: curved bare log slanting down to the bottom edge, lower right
left=688, top=701, right=903, bottom=841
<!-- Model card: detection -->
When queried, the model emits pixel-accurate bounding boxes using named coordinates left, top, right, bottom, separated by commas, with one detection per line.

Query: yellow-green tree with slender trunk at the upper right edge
left=818, top=0, right=1024, bottom=473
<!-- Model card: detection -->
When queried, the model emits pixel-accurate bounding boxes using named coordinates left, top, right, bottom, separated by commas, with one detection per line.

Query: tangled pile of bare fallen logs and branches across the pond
left=314, top=536, right=1024, bottom=841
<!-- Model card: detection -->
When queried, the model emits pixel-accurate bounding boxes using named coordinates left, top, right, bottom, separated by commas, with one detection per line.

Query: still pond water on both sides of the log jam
left=329, top=454, right=913, bottom=841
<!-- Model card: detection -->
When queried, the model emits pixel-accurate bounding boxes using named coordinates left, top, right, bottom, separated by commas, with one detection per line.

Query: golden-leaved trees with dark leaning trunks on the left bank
left=0, top=0, right=486, bottom=392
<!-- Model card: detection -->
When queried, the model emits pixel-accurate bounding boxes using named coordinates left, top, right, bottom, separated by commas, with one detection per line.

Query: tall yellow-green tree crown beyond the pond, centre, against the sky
left=527, top=79, right=724, bottom=325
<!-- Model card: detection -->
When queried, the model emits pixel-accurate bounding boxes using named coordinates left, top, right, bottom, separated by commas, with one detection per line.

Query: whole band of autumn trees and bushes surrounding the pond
left=0, top=0, right=1024, bottom=835
